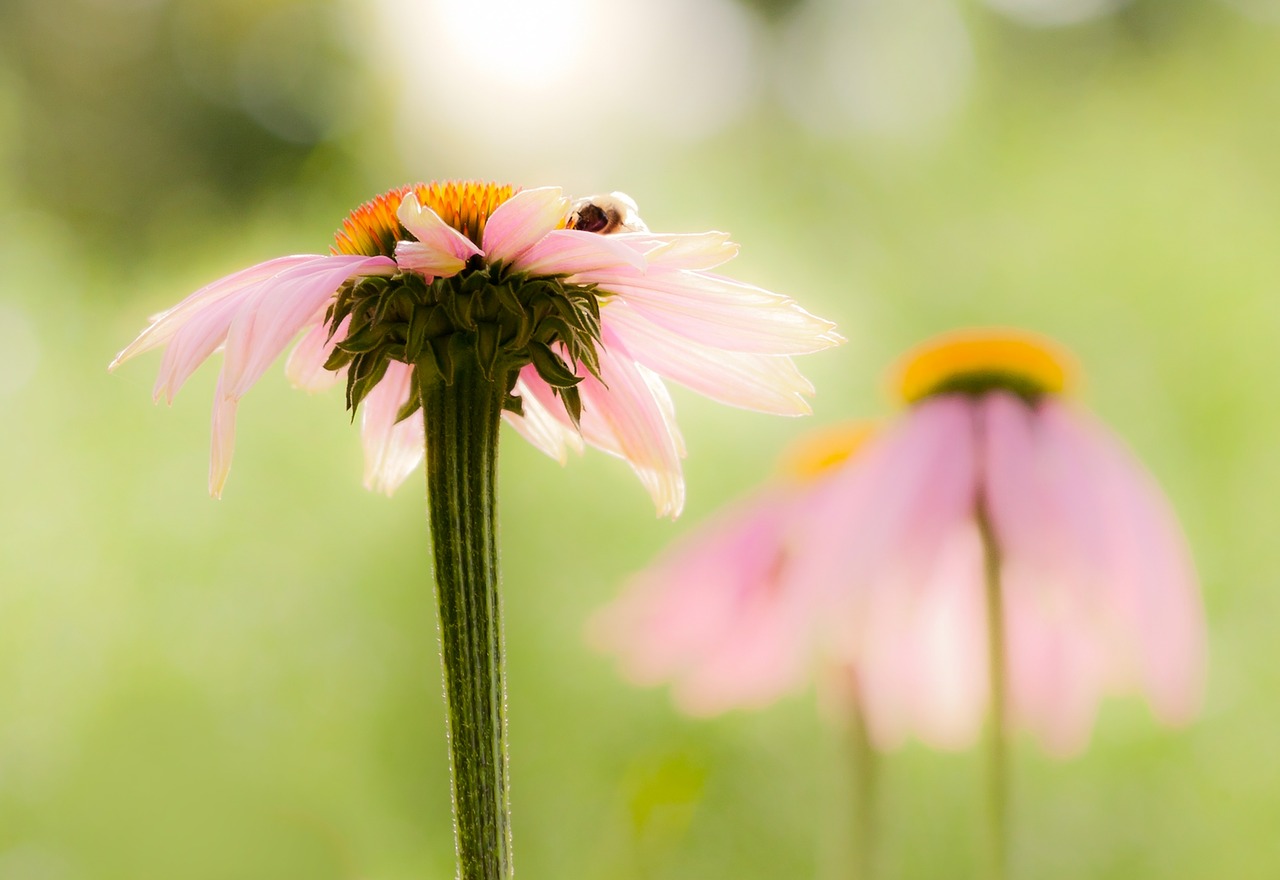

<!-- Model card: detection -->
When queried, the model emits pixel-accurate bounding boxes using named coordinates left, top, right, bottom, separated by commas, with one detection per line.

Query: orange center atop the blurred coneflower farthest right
left=895, top=330, right=1075, bottom=403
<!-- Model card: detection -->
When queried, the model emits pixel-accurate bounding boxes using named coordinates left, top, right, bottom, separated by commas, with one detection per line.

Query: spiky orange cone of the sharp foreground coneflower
left=330, top=180, right=516, bottom=257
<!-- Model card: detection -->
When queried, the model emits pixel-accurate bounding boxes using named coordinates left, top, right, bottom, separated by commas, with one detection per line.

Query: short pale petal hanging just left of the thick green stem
left=360, top=361, right=426, bottom=495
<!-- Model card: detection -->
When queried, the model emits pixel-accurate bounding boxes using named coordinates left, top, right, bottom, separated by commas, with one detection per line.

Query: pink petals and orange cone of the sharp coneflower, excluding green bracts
left=111, top=182, right=841, bottom=515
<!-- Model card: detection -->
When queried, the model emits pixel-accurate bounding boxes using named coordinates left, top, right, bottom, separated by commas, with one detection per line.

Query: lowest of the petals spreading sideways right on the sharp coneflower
left=600, top=301, right=813, bottom=416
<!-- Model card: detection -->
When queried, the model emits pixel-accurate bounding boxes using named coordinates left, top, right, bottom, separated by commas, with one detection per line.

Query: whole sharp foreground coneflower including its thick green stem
left=111, top=176, right=840, bottom=880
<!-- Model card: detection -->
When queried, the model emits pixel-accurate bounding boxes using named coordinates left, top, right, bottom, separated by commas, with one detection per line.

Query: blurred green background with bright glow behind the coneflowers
left=0, top=0, right=1280, bottom=880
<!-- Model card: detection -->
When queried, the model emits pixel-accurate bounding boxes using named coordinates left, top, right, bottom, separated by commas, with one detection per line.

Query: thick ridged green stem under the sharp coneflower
left=417, top=356, right=512, bottom=880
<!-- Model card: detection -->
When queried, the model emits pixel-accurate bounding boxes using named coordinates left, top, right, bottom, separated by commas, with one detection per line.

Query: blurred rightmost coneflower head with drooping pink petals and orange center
left=796, top=331, right=1204, bottom=755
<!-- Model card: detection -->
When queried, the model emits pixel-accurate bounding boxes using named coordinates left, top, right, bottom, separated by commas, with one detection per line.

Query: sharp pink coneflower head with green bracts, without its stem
left=111, top=182, right=840, bottom=515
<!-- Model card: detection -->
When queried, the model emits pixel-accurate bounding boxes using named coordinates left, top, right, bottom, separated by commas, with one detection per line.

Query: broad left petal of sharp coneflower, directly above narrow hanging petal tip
left=223, top=255, right=396, bottom=397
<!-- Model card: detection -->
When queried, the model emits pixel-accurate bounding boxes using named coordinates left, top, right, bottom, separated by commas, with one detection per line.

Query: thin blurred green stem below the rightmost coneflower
left=977, top=500, right=1009, bottom=880
